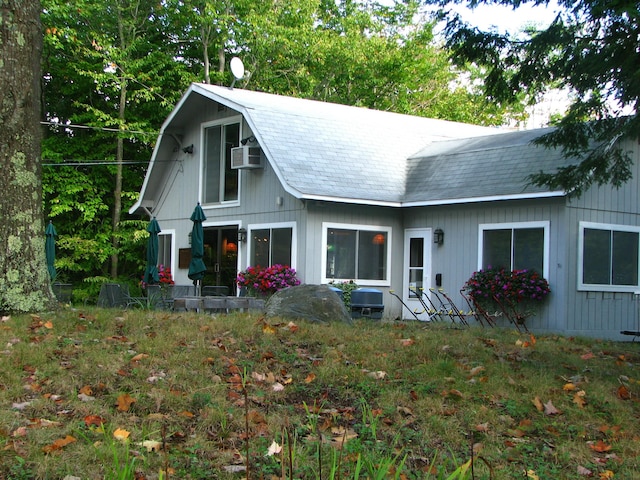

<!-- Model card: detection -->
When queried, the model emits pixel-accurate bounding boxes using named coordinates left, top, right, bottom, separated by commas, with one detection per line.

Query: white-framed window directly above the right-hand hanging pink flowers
left=478, top=222, right=549, bottom=278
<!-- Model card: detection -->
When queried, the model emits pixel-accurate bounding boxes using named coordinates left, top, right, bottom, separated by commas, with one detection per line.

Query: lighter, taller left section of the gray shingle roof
left=195, top=85, right=496, bottom=204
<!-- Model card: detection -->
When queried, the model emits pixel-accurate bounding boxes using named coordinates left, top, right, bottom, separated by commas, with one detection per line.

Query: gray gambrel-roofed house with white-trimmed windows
left=130, top=84, right=640, bottom=339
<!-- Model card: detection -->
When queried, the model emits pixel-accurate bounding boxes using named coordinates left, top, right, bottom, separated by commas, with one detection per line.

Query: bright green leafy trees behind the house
left=42, top=0, right=522, bottom=286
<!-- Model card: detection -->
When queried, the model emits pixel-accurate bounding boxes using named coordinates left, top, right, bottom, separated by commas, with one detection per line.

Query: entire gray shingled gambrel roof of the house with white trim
left=131, top=84, right=562, bottom=212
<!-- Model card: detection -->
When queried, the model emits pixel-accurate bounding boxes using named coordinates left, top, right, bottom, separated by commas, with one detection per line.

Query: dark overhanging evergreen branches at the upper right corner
left=425, top=0, right=640, bottom=196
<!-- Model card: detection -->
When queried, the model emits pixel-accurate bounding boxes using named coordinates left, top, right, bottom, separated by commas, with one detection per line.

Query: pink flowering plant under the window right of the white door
left=464, top=268, right=551, bottom=304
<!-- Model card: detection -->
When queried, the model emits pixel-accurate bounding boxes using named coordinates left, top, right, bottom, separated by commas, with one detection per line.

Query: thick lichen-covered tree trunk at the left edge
left=0, top=0, right=53, bottom=312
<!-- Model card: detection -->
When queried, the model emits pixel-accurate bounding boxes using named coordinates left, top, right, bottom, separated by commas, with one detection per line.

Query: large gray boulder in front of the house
left=265, top=284, right=351, bottom=323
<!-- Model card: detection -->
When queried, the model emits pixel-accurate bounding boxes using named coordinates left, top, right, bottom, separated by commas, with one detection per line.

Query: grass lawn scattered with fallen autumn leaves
left=0, top=309, right=640, bottom=480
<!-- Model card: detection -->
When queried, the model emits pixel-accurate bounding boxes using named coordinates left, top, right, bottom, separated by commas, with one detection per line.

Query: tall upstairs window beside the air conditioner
left=202, top=122, right=240, bottom=204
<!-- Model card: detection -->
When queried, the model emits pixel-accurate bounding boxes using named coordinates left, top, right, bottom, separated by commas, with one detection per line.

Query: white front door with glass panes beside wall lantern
left=401, top=228, right=432, bottom=320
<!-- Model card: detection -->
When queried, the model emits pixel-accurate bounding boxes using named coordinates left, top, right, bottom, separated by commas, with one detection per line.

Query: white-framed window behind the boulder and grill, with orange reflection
left=322, top=224, right=391, bottom=285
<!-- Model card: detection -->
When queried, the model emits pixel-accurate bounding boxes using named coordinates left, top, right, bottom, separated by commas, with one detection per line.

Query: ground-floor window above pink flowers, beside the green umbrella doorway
left=249, top=224, right=295, bottom=268
